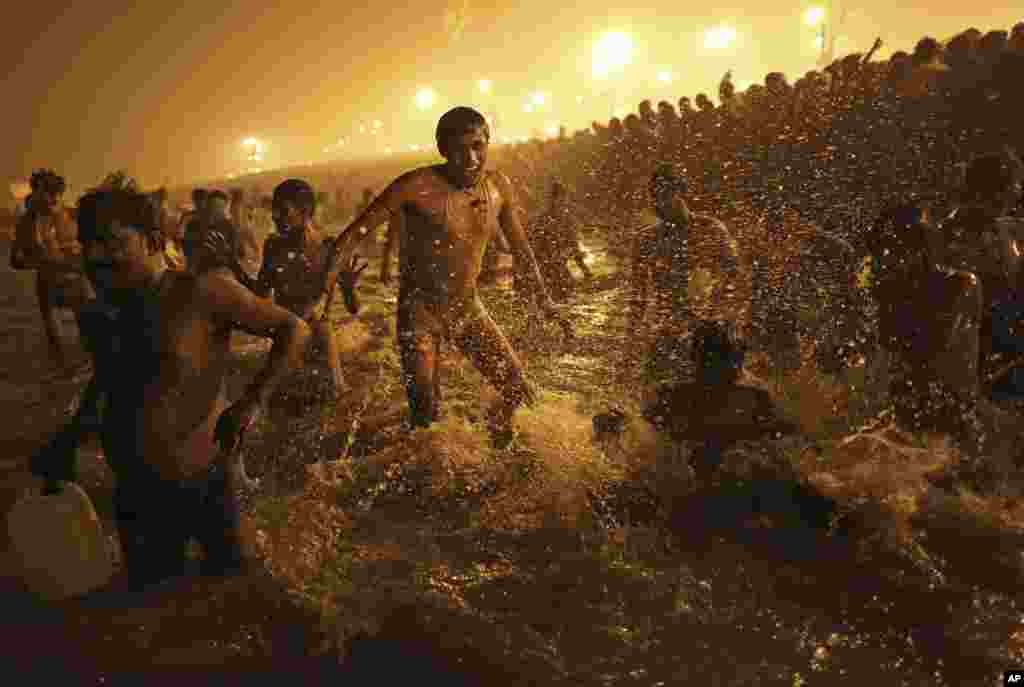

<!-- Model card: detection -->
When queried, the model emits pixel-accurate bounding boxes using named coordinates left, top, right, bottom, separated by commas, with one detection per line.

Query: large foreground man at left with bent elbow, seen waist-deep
left=32, top=189, right=309, bottom=585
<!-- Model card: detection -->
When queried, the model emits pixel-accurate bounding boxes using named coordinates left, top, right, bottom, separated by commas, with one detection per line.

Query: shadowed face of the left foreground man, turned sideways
left=79, top=219, right=153, bottom=295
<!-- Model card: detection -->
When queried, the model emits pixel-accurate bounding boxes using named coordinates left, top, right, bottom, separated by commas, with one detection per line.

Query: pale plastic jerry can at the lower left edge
left=7, top=482, right=114, bottom=601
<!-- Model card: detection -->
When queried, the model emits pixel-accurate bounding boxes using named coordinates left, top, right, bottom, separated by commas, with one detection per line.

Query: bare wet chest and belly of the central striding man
left=399, top=168, right=502, bottom=309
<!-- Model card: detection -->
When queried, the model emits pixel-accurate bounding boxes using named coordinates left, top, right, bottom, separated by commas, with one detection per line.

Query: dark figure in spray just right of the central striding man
left=514, top=181, right=594, bottom=301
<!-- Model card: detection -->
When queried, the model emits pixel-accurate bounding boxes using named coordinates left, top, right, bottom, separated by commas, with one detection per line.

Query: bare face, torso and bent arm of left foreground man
left=83, top=221, right=309, bottom=479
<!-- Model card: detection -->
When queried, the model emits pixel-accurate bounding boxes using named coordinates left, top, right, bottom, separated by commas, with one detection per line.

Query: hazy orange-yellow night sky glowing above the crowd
left=0, top=0, right=1024, bottom=188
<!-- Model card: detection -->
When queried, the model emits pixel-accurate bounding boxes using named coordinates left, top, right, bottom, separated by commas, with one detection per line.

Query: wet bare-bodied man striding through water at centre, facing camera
left=329, top=108, right=569, bottom=445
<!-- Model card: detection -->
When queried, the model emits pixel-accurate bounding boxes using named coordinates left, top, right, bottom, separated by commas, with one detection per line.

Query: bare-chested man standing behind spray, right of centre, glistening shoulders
left=630, top=164, right=750, bottom=381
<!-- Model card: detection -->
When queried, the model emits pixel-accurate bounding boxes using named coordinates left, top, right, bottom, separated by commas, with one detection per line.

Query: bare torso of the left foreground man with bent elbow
left=102, top=272, right=230, bottom=479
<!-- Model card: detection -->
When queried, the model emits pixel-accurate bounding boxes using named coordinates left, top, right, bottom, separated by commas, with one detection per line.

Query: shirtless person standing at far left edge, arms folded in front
left=10, top=170, right=95, bottom=367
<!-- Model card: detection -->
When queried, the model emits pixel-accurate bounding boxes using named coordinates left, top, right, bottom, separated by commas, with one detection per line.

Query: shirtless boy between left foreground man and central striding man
left=236, top=179, right=352, bottom=394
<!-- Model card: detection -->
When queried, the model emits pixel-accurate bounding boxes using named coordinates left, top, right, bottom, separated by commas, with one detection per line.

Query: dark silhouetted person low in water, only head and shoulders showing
left=643, top=321, right=799, bottom=481
